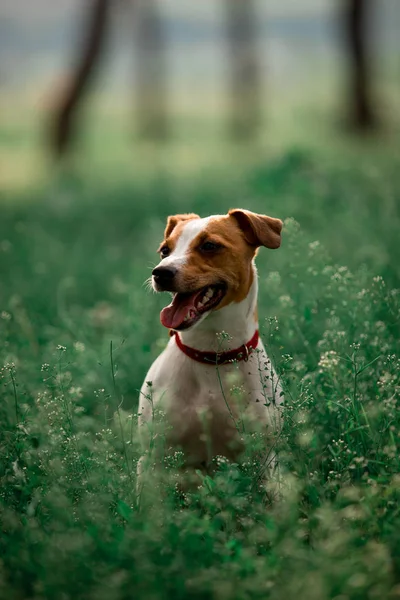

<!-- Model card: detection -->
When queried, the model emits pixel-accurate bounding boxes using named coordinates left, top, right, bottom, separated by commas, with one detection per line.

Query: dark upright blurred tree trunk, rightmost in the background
left=343, top=0, right=377, bottom=131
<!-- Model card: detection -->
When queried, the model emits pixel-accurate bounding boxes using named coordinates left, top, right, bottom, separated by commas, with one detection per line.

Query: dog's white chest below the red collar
left=139, top=340, right=280, bottom=465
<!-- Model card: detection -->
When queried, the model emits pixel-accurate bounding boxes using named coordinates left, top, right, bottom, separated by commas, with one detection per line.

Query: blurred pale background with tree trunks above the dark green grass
left=0, top=0, right=400, bottom=188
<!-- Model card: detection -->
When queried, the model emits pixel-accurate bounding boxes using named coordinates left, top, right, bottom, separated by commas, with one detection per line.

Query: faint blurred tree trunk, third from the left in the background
left=225, top=0, right=262, bottom=139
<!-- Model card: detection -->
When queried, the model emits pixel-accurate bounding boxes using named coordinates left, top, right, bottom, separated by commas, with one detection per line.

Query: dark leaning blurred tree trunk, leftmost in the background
left=51, top=0, right=111, bottom=157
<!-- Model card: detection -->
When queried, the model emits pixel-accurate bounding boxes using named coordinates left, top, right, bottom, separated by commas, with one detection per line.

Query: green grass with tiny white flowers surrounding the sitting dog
left=0, top=147, right=400, bottom=600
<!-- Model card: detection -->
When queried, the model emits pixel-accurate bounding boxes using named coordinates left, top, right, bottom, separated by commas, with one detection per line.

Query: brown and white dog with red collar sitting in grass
left=138, top=209, right=283, bottom=490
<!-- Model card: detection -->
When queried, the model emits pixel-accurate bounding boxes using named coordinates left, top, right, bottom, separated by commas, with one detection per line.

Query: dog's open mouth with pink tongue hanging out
left=160, top=285, right=226, bottom=331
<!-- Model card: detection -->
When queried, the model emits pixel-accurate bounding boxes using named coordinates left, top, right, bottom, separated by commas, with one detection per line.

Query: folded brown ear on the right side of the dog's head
left=228, top=208, right=283, bottom=249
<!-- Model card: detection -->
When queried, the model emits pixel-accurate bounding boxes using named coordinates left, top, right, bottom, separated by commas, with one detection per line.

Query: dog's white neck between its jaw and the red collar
left=179, top=263, right=258, bottom=351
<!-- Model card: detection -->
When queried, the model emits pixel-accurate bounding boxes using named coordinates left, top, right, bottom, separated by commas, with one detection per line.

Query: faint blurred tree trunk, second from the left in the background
left=135, top=0, right=169, bottom=140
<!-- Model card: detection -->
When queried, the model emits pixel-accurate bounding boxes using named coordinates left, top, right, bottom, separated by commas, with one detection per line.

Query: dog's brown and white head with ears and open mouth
left=152, top=209, right=282, bottom=331
